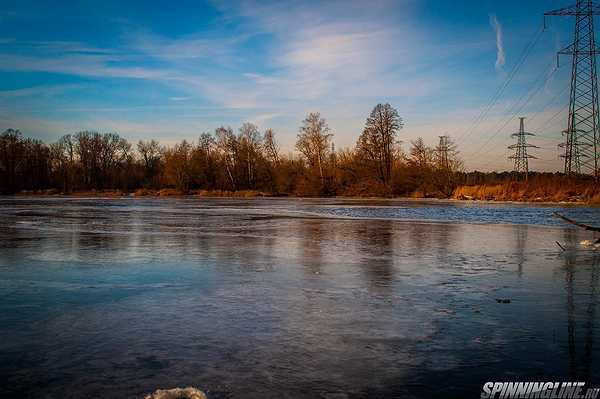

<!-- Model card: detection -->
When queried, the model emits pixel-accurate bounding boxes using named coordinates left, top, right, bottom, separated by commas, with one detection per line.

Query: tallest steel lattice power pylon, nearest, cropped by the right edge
left=544, top=0, right=600, bottom=178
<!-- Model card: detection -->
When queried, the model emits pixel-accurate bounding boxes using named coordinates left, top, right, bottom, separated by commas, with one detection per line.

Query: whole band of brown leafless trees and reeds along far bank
left=0, top=104, right=600, bottom=202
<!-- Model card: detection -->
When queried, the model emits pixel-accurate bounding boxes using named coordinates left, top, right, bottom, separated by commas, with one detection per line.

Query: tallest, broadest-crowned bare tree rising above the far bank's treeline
left=357, top=103, right=403, bottom=184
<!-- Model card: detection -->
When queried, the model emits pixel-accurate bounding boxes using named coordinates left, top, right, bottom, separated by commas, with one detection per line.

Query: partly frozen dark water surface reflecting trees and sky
left=0, top=198, right=600, bottom=399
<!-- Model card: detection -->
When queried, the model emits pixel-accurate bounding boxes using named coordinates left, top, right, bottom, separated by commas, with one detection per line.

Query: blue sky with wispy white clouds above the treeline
left=0, top=0, right=574, bottom=171
